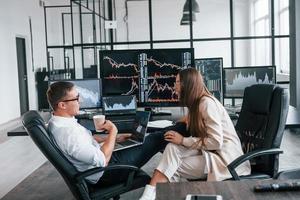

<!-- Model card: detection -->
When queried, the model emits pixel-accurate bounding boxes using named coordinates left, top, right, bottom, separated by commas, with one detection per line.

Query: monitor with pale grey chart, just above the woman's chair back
left=223, top=66, right=276, bottom=98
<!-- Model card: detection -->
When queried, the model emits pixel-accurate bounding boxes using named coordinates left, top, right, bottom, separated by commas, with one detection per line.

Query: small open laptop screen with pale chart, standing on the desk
left=102, top=95, right=137, bottom=115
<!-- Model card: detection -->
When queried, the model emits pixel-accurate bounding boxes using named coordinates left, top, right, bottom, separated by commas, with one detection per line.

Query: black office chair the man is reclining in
left=23, top=111, right=150, bottom=200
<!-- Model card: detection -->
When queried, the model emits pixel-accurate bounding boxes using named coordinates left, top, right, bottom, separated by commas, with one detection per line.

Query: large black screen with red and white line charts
left=100, top=49, right=194, bottom=106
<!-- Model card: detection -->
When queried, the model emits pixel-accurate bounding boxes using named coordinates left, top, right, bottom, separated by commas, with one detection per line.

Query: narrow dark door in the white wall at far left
left=16, top=37, right=29, bottom=115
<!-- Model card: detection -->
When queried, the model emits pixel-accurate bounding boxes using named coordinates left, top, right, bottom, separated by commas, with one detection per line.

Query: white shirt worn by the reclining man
left=48, top=115, right=106, bottom=183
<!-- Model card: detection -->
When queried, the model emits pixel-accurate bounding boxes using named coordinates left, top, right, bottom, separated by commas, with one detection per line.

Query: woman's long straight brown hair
left=179, top=68, right=212, bottom=143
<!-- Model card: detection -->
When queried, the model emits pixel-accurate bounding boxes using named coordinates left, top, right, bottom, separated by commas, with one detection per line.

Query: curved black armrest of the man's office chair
left=76, top=165, right=140, bottom=181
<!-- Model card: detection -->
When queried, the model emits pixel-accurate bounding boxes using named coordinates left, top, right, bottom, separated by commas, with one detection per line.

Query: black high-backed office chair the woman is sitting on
left=228, top=84, right=289, bottom=180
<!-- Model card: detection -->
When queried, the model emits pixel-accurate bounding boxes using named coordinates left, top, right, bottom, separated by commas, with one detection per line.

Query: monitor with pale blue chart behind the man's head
left=49, top=79, right=101, bottom=109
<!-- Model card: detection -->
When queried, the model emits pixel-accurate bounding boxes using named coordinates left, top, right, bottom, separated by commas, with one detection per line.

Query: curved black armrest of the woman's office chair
left=227, top=148, right=283, bottom=180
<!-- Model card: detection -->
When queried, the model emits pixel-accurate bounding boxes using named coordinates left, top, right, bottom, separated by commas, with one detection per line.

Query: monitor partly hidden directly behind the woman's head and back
left=195, top=58, right=223, bottom=102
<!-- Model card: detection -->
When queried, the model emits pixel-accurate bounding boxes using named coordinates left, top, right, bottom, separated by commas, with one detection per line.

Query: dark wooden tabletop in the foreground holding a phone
left=156, top=180, right=300, bottom=200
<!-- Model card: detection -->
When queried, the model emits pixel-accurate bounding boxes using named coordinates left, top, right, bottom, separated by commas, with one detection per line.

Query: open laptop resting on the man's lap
left=114, top=111, right=150, bottom=151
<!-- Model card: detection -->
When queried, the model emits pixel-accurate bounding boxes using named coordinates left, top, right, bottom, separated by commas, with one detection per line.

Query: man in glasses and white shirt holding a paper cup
left=47, top=81, right=166, bottom=186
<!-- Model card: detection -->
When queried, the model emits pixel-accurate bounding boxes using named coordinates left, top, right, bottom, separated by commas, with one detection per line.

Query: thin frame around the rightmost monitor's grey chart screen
left=222, top=65, right=276, bottom=99
